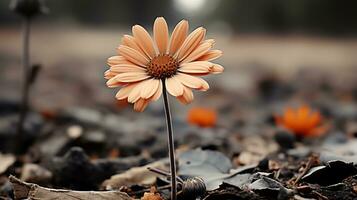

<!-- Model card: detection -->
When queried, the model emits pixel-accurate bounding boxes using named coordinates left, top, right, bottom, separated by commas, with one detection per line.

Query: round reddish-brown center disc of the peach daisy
left=147, top=54, right=179, bottom=79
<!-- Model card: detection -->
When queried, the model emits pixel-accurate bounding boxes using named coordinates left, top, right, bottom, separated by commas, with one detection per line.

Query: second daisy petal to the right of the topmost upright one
left=177, top=27, right=206, bottom=62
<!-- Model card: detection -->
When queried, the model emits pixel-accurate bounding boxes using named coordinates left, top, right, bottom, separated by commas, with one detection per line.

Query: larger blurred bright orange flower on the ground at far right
left=275, top=106, right=327, bottom=136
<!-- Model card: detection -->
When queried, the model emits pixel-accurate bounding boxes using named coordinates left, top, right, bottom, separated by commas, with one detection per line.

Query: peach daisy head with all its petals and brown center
left=104, top=17, right=223, bottom=112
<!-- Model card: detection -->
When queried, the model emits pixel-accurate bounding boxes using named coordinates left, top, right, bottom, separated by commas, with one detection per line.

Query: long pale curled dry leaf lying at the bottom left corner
left=9, top=176, right=133, bottom=200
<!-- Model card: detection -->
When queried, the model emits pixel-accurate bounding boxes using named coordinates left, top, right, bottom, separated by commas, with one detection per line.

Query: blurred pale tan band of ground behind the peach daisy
left=0, top=25, right=357, bottom=109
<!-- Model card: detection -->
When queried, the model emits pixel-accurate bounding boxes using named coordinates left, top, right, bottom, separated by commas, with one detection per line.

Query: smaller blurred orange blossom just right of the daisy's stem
left=187, top=108, right=217, bottom=127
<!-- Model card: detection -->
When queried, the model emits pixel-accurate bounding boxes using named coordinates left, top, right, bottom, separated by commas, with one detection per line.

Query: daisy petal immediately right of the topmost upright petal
left=169, top=20, right=188, bottom=55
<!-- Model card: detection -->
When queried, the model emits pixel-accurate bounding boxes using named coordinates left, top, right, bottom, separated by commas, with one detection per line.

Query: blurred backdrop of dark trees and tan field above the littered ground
left=0, top=0, right=357, bottom=110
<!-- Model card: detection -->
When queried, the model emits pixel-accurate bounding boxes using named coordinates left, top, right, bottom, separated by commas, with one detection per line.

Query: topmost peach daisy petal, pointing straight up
left=154, top=17, right=169, bottom=54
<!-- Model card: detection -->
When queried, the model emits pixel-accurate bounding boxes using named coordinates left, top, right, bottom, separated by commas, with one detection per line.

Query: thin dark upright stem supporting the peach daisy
left=162, top=79, right=177, bottom=200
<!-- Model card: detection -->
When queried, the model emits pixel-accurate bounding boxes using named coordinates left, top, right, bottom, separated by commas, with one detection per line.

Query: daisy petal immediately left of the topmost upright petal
left=132, top=25, right=156, bottom=58
